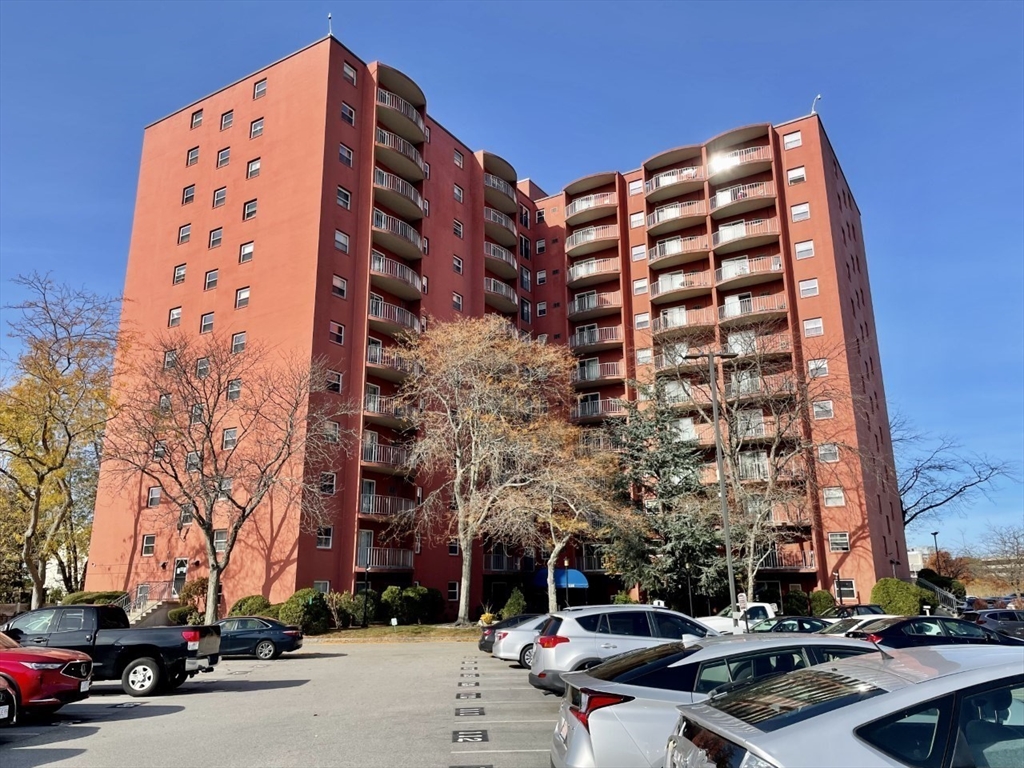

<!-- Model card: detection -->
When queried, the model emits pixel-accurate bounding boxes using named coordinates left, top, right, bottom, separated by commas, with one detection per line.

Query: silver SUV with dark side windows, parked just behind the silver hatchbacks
left=529, top=605, right=719, bottom=693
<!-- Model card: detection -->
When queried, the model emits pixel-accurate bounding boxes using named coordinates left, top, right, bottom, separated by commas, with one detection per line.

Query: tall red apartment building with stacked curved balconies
left=87, top=37, right=907, bottom=607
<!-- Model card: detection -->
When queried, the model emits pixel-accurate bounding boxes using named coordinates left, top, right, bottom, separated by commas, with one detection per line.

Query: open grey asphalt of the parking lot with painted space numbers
left=0, top=642, right=559, bottom=768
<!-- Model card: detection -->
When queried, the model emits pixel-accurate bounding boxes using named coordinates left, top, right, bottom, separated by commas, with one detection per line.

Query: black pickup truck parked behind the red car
left=0, top=605, right=220, bottom=696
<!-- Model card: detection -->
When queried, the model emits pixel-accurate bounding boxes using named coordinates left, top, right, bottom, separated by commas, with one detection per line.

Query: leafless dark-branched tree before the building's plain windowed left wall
left=104, top=334, right=354, bottom=624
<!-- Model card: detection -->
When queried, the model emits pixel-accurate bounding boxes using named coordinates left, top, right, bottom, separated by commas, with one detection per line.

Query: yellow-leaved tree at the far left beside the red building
left=0, top=273, right=119, bottom=608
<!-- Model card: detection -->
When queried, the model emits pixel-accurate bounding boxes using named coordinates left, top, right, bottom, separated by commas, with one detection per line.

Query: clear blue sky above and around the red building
left=0, top=0, right=1024, bottom=544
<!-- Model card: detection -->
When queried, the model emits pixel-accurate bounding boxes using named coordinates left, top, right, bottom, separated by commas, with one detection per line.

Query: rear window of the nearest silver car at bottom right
left=708, top=670, right=885, bottom=732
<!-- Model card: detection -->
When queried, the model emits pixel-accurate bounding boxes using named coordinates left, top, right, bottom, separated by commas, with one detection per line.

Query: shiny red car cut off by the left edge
left=0, top=633, right=92, bottom=713
